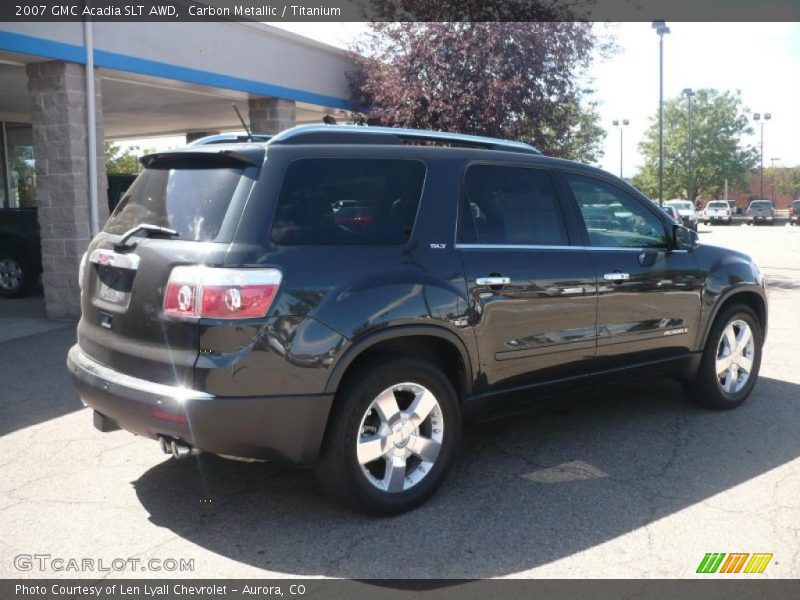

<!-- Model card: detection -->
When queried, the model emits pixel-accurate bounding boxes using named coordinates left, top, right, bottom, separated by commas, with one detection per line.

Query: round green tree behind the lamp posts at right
left=633, top=89, right=759, bottom=201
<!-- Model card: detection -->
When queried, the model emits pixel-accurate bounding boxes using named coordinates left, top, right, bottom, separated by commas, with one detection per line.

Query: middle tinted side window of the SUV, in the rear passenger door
left=458, top=165, right=569, bottom=246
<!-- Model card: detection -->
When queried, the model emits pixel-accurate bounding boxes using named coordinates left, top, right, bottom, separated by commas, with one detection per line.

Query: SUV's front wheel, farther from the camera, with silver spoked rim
left=686, top=304, right=764, bottom=410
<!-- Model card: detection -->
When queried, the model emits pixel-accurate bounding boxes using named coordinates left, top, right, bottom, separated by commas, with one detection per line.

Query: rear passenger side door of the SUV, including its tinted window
left=456, top=164, right=596, bottom=391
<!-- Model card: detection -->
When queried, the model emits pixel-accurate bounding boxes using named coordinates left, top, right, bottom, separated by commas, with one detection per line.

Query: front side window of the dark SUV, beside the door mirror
left=565, top=174, right=667, bottom=248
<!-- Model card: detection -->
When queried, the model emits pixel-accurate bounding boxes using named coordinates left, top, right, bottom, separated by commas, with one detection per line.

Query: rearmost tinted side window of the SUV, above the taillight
left=272, top=158, right=425, bottom=245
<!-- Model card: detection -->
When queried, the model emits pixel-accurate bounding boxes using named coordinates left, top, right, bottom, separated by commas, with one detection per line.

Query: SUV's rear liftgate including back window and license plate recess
left=78, top=149, right=263, bottom=386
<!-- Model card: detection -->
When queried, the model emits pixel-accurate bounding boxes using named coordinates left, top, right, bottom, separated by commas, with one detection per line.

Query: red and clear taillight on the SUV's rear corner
left=164, top=265, right=281, bottom=319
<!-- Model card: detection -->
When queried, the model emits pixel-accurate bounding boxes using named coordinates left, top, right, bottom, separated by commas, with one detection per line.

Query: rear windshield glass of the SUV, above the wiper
left=104, top=168, right=242, bottom=242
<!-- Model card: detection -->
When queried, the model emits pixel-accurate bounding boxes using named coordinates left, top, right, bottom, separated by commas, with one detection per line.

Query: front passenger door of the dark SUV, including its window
left=563, top=173, right=702, bottom=368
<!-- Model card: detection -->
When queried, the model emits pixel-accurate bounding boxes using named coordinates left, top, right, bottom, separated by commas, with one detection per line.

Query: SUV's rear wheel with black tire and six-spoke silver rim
left=316, top=355, right=461, bottom=516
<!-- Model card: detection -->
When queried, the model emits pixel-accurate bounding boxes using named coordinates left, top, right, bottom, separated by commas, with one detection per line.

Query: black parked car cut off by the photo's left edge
left=0, top=208, right=42, bottom=298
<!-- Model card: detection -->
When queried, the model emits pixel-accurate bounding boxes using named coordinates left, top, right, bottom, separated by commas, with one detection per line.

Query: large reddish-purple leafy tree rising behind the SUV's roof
left=350, top=22, right=607, bottom=162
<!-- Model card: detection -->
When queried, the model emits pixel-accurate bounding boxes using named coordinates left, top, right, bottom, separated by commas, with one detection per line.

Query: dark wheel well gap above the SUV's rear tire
left=332, top=335, right=467, bottom=400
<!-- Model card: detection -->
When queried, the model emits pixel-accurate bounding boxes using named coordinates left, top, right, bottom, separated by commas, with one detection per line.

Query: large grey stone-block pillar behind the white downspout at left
left=25, top=61, right=108, bottom=319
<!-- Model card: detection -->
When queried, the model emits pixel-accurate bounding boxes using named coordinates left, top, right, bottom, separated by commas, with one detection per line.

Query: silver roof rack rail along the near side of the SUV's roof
left=268, top=125, right=541, bottom=154
